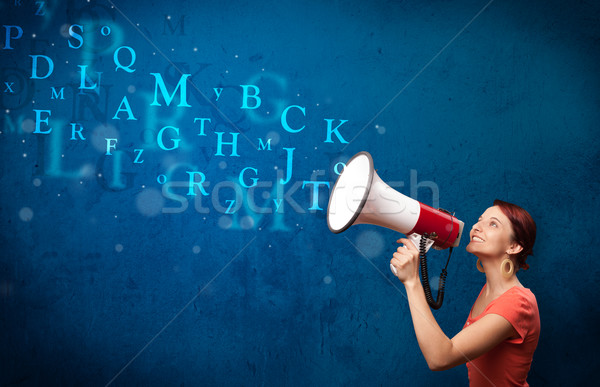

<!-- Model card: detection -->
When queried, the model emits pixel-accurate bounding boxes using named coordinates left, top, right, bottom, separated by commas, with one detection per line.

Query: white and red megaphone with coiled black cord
left=327, top=151, right=464, bottom=309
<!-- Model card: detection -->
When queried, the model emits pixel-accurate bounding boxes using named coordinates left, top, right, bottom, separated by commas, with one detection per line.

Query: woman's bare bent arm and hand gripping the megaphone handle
left=391, top=238, right=516, bottom=371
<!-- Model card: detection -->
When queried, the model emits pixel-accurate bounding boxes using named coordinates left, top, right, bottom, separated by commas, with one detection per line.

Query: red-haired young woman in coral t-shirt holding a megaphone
left=391, top=200, right=540, bottom=386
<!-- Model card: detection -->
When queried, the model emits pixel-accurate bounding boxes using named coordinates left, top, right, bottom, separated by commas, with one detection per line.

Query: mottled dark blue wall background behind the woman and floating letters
left=0, top=0, right=600, bottom=386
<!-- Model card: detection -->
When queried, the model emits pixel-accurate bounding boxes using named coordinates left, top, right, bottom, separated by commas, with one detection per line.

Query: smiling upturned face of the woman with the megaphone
left=467, top=206, right=514, bottom=257
